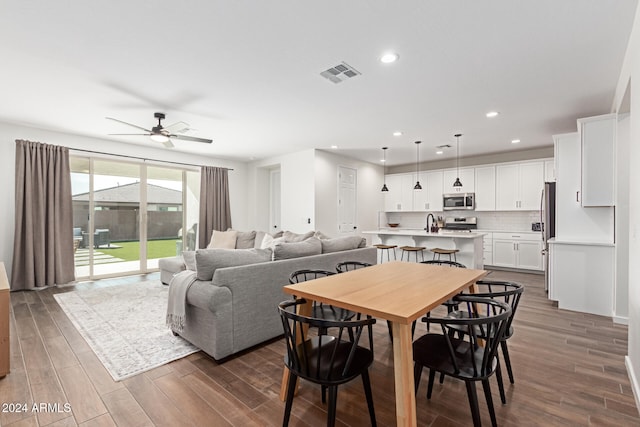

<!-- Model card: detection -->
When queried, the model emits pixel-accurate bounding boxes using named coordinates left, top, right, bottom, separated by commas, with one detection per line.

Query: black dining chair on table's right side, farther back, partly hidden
left=448, top=280, right=524, bottom=403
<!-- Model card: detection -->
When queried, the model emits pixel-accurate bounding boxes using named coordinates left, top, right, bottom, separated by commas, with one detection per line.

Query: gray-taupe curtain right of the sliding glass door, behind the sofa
left=198, top=166, right=231, bottom=248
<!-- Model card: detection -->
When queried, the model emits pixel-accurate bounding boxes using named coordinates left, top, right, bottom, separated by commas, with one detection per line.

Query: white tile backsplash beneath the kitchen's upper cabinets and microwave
left=379, top=211, right=540, bottom=231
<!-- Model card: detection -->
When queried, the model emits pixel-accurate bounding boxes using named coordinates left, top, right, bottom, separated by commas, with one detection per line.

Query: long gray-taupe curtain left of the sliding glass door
left=11, top=140, right=75, bottom=290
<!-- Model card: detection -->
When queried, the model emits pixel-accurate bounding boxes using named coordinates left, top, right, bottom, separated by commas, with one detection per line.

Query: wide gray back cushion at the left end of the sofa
left=196, top=248, right=271, bottom=280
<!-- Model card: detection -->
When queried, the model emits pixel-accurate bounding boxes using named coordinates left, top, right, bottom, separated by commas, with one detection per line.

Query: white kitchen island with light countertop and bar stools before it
left=363, top=228, right=484, bottom=270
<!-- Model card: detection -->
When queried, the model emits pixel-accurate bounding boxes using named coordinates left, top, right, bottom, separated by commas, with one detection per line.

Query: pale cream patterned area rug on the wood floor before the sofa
left=54, top=280, right=198, bottom=381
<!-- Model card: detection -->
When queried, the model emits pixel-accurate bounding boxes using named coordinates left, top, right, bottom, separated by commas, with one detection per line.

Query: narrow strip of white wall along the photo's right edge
left=613, top=2, right=640, bottom=407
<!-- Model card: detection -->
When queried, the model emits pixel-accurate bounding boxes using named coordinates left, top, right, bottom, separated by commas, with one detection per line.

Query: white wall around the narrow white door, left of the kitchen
left=315, top=150, right=384, bottom=236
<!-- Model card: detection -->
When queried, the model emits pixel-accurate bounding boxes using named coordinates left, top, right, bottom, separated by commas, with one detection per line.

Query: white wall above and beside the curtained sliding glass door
left=0, top=123, right=247, bottom=277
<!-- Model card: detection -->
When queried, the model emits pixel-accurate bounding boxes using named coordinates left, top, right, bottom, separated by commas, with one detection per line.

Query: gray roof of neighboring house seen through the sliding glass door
left=73, top=182, right=182, bottom=205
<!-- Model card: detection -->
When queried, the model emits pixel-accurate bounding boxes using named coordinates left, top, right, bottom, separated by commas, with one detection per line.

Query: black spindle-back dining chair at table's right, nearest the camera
left=413, top=295, right=511, bottom=426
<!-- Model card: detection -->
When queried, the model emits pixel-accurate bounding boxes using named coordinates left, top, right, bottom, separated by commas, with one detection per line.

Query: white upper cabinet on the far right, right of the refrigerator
left=578, top=114, right=617, bottom=206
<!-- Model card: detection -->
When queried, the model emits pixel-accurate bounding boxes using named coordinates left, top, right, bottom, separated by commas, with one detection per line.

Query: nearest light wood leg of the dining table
left=391, top=322, right=417, bottom=426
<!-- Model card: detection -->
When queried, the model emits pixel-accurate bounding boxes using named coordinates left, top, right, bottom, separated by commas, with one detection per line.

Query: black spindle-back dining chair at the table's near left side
left=278, top=299, right=377, bottom=426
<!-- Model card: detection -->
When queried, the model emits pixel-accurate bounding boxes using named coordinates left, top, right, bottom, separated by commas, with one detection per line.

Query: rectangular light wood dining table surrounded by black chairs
left=280, top=261, right=488, bottom=426
